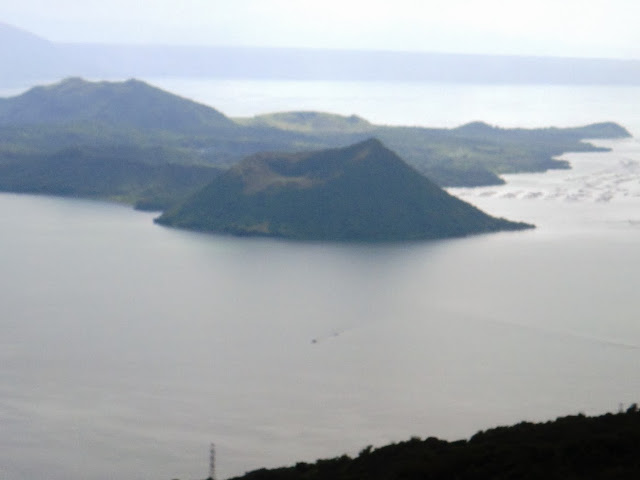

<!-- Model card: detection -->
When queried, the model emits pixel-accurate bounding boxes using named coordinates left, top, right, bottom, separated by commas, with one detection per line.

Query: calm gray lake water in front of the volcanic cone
left=0, top=80, right=640, bottom=480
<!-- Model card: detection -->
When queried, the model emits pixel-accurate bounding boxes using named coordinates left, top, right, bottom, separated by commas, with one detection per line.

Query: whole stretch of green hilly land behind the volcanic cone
left=0, top=78, right=629, bottom=231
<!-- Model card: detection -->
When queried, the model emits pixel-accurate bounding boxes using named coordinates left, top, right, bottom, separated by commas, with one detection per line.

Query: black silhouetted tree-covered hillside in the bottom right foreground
left=224, top=405, right=640, bottom=480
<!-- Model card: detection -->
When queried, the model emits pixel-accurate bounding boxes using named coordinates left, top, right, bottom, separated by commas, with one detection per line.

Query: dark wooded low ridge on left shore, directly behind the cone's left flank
left=0, top=147, right=221, bottom=210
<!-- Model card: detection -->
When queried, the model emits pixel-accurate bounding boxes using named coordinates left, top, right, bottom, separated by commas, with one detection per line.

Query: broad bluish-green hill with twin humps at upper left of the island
left=0, top=78, right=236, bottom=134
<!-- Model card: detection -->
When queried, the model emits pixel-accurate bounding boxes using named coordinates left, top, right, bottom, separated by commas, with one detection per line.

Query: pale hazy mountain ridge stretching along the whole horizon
left=0, top=24, right=640, bottom=86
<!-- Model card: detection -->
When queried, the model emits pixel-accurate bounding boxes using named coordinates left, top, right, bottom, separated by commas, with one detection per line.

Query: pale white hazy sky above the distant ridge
left=0, top=0, right=640, bottom=58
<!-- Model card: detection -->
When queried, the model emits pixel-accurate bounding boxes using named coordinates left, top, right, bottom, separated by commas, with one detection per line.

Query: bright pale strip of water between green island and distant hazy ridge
left=147, top=78, right=640, bottom=136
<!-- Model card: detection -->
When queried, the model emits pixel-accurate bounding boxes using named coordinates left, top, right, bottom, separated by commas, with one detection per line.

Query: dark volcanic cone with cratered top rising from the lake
left=157, top=139, right=531, bottom=241
